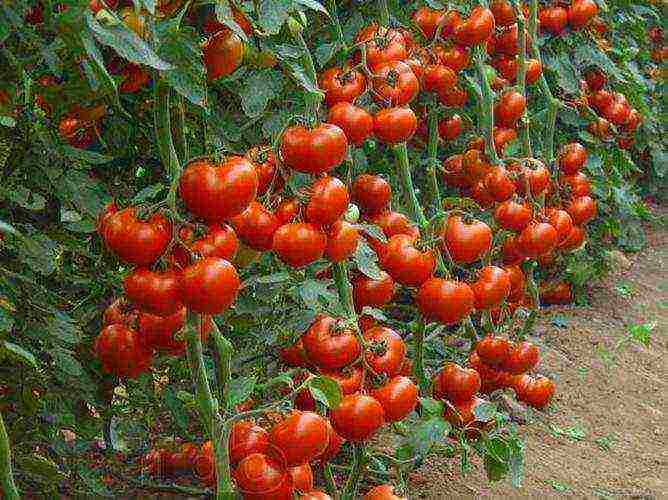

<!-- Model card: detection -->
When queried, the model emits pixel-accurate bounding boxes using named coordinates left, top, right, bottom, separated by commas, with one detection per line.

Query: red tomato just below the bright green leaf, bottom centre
left=330, top=394, right=385, bottom=441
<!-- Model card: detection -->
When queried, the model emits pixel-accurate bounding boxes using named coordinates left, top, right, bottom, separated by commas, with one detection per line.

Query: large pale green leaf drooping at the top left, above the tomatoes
left=85, top=9, right=172, bottom=71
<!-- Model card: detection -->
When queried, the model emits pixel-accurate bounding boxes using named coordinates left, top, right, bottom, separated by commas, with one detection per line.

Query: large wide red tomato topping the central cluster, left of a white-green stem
left=281, top=123, right=348, bottom=175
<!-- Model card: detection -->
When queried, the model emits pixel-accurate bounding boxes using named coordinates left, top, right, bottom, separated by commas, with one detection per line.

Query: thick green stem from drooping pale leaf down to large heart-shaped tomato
left=153, top=79, right=181, bottom=211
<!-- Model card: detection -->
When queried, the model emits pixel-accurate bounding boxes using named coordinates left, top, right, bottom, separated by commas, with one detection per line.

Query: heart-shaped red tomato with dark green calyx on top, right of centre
left=441, top=215, right=492, bottom=263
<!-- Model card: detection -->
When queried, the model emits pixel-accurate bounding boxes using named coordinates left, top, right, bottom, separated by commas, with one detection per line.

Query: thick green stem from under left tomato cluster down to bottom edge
left=186, top=318, right=234, bottom=500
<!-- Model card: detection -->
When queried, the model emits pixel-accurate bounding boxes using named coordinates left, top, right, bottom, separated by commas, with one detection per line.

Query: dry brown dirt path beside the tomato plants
left=410, top=221, right=668, bottom=499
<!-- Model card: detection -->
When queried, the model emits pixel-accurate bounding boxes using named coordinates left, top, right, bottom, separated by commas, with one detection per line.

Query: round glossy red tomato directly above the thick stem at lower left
left=181, top=257, right=241, bottom=314
